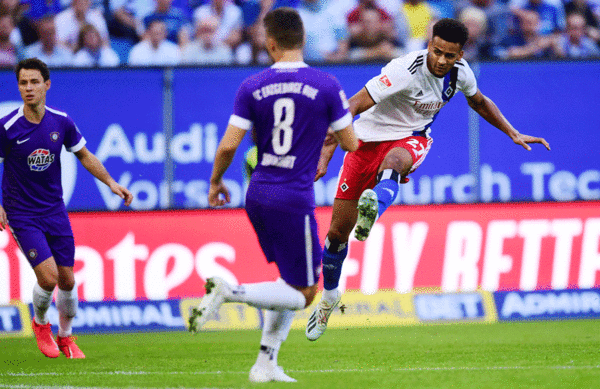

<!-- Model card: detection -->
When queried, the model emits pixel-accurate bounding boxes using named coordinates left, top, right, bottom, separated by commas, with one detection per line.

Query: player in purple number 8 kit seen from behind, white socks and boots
left=190, top=8, right=358, bottom=382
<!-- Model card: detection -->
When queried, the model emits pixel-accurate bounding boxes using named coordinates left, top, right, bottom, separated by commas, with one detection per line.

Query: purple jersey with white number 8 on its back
left=229, top=62, right=352, bottom=211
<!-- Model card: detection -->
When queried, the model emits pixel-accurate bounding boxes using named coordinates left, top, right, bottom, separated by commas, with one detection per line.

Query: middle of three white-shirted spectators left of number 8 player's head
left=128, top=20, right=181, bottom=66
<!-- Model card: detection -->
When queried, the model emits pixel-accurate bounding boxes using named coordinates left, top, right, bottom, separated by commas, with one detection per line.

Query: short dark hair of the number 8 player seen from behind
left=263, top=7, right=304, bottom=50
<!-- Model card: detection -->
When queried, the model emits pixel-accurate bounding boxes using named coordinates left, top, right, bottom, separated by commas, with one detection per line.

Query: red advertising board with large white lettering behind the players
left=0, top=202, right=600, bottom=305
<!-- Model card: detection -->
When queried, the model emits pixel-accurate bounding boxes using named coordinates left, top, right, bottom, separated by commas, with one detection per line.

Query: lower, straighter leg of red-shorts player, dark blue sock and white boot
left=306, top=199, right=357, bottom=340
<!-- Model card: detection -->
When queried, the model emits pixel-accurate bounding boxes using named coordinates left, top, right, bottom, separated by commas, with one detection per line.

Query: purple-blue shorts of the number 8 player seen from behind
left=246, top=198, right=323, bottom=287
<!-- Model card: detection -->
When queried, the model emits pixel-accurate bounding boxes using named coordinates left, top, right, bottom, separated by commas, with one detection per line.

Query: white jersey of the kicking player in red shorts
left=354, top=50, right=477, bottom=142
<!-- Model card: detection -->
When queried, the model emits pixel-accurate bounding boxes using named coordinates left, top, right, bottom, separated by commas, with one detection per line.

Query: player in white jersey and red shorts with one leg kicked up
left=306, top=19, right=550, bottom=340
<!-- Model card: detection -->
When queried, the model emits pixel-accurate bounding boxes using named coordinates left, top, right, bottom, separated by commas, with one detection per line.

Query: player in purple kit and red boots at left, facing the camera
left=0, top=58, right=133, bottom=358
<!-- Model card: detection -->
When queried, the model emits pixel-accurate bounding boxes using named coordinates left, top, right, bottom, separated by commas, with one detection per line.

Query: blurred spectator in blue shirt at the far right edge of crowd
left=558, top=12, right=600, bottom=58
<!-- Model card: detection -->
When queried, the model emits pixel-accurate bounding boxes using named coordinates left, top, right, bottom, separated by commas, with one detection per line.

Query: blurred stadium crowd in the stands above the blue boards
left=0, top=0, right=600, bottom=67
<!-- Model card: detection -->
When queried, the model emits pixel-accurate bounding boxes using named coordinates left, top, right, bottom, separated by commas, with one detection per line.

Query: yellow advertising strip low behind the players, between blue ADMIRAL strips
left=180, top=289, right=498, bottom=330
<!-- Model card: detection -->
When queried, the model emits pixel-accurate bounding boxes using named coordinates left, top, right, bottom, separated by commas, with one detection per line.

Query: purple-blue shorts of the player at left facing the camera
left=8, top=211, right=75, bottom=268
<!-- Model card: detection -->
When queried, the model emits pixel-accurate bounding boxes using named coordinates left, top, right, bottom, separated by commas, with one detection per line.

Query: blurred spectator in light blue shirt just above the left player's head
left=25, top=15, right=73, bottom=67
